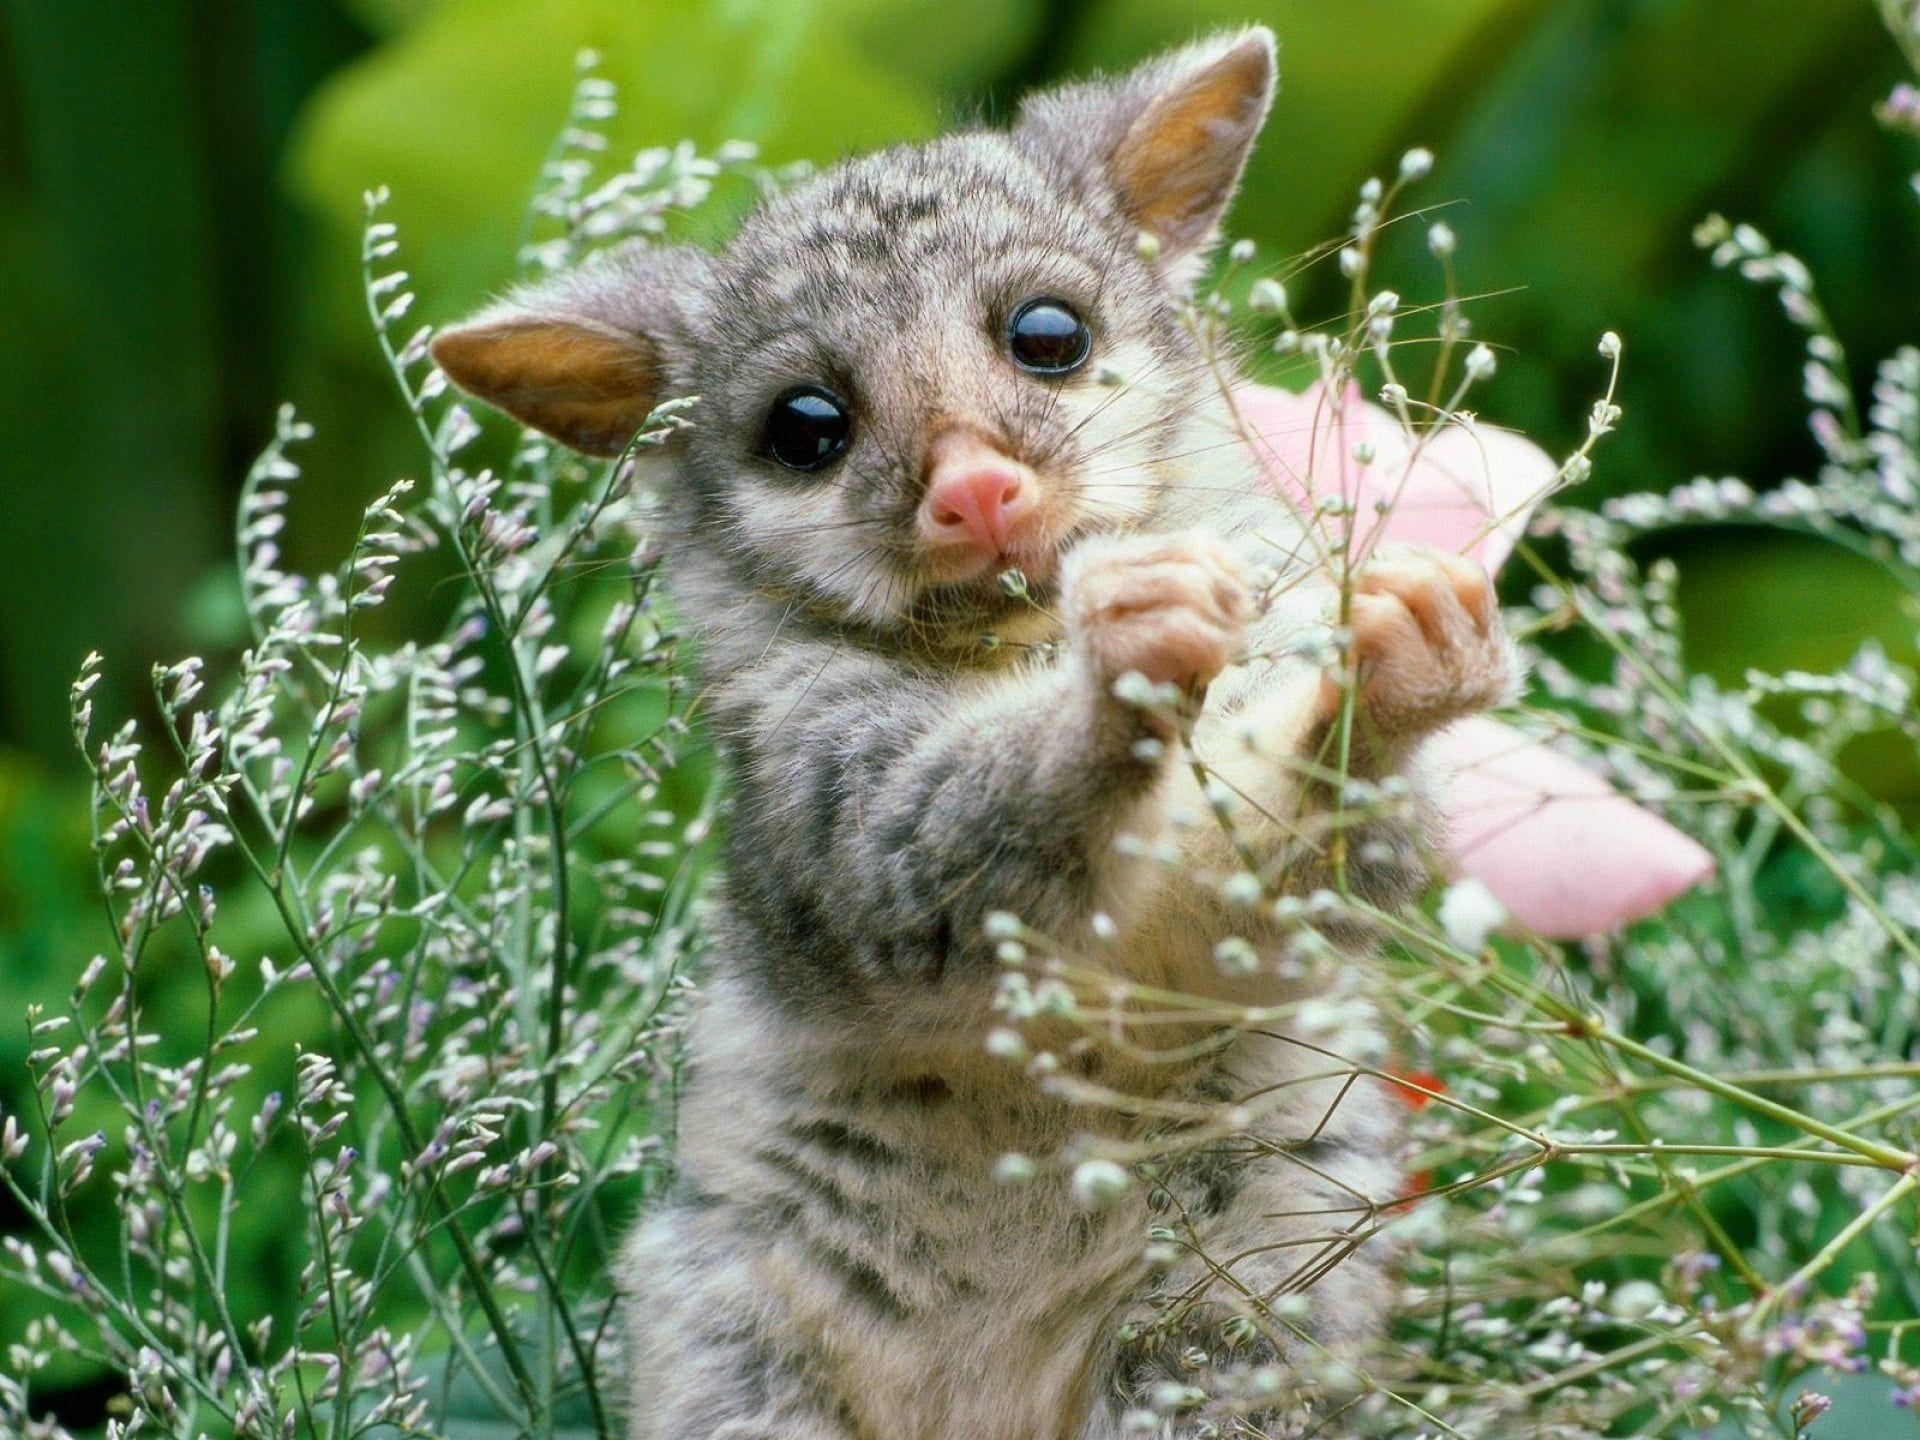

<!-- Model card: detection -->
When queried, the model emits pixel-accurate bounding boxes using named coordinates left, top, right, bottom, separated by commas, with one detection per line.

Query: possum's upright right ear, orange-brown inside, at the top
left=1014, top=25, right=1273, bottom=273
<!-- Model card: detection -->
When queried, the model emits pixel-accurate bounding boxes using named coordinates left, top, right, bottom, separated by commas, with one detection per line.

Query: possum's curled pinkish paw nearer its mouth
left=1062, top=536, right=1252, bottom=691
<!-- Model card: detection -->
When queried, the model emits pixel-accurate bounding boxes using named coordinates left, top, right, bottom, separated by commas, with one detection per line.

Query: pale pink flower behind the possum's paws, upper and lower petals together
left=1235, top=386, right=1713, bottom=939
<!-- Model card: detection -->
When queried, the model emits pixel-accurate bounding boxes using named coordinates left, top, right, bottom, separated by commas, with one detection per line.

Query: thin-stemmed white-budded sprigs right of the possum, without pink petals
left=989, top=118, right=1920, bottom=1440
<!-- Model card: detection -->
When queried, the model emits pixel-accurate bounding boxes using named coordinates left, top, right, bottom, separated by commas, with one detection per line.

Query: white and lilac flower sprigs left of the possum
left=0, top=50, right=721, bottom=1438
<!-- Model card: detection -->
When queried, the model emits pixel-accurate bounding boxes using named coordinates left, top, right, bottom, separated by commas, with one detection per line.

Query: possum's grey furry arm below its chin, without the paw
left=733, top=653, right=1165, bottom=977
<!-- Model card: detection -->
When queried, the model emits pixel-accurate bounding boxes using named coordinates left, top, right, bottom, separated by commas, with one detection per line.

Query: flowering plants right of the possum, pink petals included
left=996, top=42, right=1920, bottom=1440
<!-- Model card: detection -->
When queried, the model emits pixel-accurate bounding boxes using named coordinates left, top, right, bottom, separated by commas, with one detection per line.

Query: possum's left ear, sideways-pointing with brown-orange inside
left=432, top=242, right=710, bottom=455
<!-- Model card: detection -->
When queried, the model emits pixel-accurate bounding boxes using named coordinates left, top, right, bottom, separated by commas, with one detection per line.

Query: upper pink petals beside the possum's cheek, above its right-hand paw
left=1233, top=384, right=1559, bottom=572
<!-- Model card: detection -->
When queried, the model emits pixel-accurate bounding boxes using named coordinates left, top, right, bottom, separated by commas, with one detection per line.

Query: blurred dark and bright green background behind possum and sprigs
left=0, top=0, right=1920, bottom=1436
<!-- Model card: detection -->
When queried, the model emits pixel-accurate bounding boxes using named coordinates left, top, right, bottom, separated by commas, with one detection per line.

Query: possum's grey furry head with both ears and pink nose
left=434, top=29, right=1273, bottom=630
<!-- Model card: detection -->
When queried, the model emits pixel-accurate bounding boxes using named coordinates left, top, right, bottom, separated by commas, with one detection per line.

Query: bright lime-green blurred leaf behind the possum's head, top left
left=290, top=0, right=939, bottom=353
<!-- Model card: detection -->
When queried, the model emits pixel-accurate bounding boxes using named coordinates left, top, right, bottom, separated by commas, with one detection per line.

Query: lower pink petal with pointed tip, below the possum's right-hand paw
left=1427, top=716, right=1713, bottom=939
